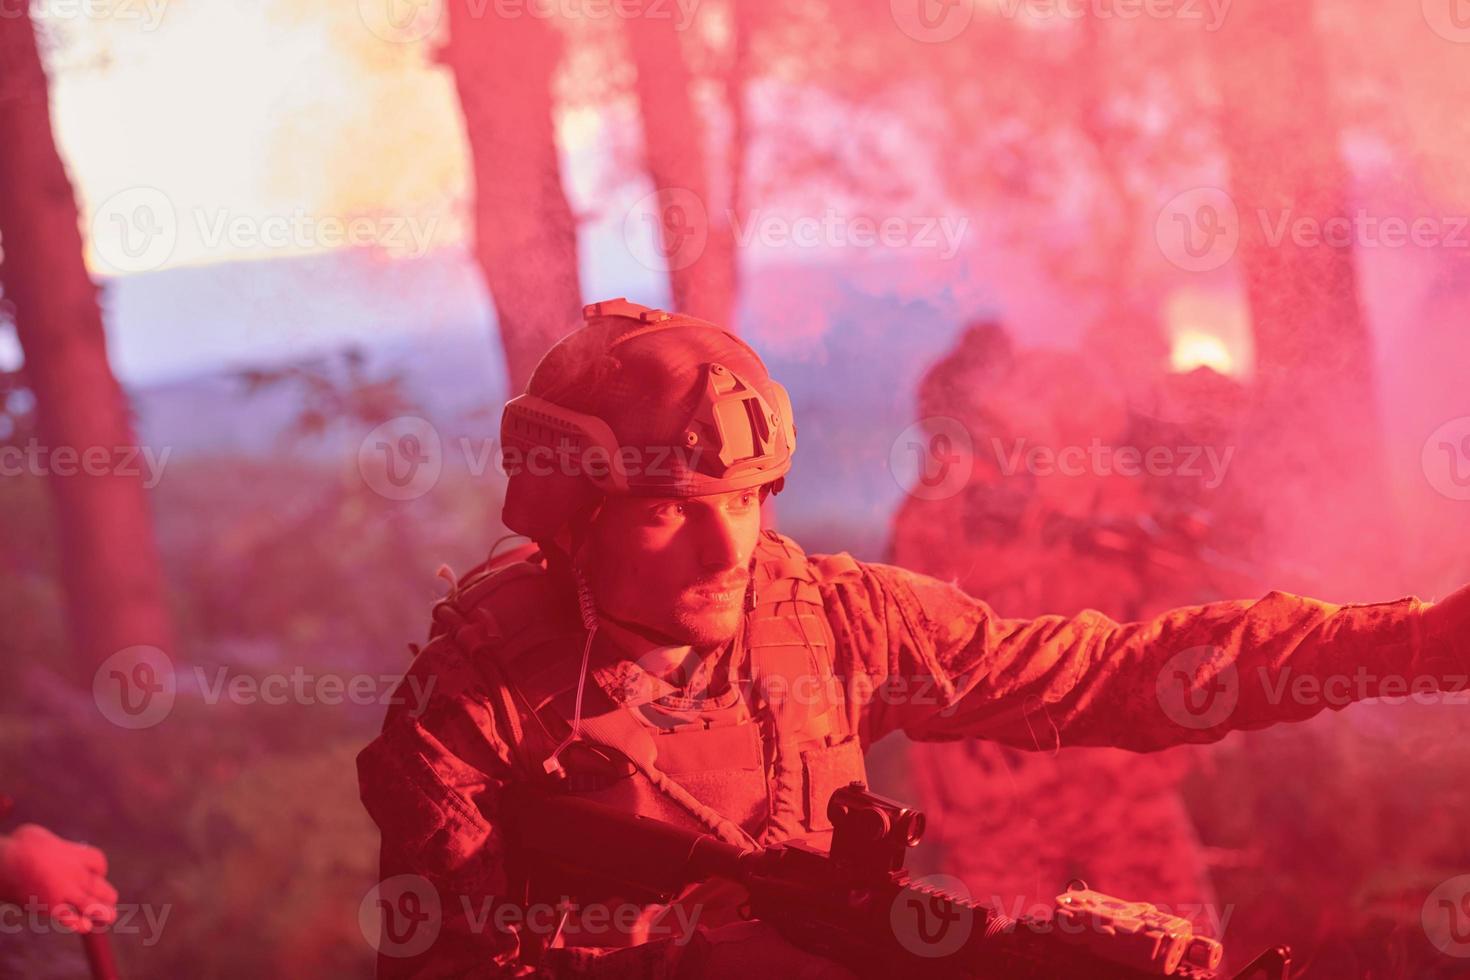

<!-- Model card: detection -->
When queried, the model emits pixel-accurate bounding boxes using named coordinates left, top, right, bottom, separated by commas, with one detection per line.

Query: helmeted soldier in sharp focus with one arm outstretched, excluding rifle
left=359, top=300, right=1470, bottom=977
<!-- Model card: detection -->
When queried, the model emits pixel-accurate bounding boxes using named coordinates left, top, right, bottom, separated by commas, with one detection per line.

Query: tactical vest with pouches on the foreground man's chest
left=431, top=530, right=866, bottom=848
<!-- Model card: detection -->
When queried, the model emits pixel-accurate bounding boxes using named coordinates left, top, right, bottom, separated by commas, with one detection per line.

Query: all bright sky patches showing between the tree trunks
left=0, top=0, right=1346, bottom=379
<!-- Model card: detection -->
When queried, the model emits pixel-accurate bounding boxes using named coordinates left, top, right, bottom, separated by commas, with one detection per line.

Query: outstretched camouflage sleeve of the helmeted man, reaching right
left=817, top=555, right=1470, bottom=751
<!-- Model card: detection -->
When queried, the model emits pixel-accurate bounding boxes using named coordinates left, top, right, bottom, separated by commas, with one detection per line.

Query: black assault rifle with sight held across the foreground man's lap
left=503, top=782, right=1291, bottom=980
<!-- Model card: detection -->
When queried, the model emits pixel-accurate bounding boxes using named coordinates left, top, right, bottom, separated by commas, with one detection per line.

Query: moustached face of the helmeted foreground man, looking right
left=587, top=489, right=761, bottom=646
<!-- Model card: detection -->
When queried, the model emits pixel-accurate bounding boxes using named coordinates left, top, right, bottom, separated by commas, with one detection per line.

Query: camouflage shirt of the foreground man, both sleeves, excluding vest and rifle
left=359, top=532, right=1445, bottom=977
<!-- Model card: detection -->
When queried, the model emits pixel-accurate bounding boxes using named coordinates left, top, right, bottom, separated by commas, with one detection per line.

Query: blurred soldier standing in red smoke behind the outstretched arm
left=888, top=323, right=1257, bottom=932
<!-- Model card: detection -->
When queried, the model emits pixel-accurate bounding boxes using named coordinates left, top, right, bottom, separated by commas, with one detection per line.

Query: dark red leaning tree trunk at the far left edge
left=0, top=16, right=173, bottom=685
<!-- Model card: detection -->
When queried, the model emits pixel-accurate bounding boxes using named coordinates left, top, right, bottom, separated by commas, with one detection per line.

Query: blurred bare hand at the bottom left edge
left=0, top=823, right=118, bottom=933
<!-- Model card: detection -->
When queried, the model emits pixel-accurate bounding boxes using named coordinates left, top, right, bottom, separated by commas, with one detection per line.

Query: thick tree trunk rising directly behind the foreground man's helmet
left=444, top=0, right=582, bottom=392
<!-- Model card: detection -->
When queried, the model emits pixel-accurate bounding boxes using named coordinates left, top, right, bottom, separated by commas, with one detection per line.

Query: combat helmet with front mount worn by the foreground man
left=500, top=298, right=797, bottom=542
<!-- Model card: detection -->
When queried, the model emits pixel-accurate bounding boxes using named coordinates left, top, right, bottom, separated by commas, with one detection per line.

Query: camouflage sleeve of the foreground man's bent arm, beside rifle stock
left=357, top=644, right=723, bottom=980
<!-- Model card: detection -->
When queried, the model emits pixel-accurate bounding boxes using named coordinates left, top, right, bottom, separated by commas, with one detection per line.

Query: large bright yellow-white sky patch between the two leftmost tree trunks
left=37, top=0, right=470, bottom=276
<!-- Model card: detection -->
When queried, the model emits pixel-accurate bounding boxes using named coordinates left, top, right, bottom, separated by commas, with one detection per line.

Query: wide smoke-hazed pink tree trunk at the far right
left=1205, top=0, right=1392, bottom=589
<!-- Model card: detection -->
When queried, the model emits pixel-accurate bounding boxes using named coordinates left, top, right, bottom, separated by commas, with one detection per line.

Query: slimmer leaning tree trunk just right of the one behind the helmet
left=628, top=6, right=744, bottom=329
